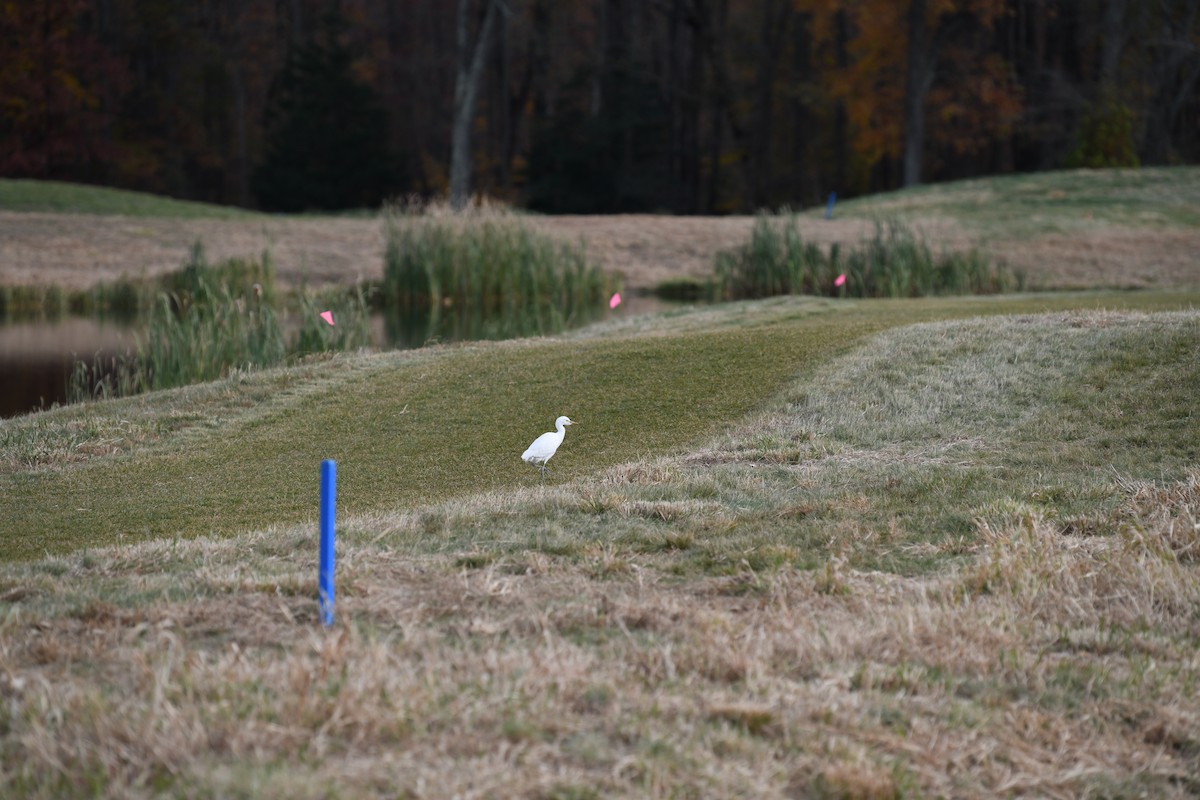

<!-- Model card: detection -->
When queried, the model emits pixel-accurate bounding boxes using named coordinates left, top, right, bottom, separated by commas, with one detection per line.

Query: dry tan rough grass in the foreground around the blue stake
left=0, top=467, right=1200, bottom=798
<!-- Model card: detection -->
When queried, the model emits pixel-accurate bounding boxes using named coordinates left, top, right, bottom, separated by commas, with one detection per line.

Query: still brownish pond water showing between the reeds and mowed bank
left=0, top=297, right=668, bottom=417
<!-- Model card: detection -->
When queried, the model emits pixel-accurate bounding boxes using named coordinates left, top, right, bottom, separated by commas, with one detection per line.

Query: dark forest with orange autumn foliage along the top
left=0, top=0, right=1200, bottom=213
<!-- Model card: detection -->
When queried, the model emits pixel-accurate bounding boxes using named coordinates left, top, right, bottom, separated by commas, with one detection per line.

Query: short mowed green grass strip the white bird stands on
left=0, top=293, right=1200, bottom=560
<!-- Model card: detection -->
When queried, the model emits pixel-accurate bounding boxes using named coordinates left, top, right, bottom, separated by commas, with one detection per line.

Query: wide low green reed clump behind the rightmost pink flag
left=714, top=215, right=1025, bottom=300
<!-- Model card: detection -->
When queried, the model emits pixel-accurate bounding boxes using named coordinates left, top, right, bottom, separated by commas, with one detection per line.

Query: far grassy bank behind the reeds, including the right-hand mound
left=0, top=167, right=1200, bottom=298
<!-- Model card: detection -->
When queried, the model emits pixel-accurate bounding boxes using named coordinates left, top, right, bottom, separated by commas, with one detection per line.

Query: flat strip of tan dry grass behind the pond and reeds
left=7, top=211, right=1200, bottom=289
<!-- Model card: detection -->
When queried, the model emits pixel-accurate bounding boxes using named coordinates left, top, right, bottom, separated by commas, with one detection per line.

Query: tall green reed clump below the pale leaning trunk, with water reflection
left=380, top=211, right=617, bottom=345
